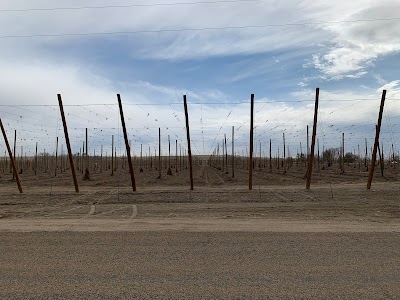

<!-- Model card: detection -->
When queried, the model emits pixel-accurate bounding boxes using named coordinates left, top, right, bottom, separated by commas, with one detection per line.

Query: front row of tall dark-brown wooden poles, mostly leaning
left=0, top=88, right=386, bottom=193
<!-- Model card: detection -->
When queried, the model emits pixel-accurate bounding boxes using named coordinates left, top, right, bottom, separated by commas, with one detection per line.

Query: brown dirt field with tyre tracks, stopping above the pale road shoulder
left=0, top=166, right=400, bottom=223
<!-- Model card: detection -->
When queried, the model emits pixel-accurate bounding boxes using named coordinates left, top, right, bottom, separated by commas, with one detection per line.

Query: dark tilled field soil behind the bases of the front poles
left=0, top=158, right=400, bottom=190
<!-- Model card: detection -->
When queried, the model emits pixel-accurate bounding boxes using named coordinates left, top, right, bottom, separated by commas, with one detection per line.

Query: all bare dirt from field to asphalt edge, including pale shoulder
left=0, top=166, right=400, bottom=232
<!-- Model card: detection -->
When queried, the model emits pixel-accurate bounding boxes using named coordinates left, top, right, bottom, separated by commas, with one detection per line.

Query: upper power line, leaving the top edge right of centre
left=0, top=0, right=260, bottom=13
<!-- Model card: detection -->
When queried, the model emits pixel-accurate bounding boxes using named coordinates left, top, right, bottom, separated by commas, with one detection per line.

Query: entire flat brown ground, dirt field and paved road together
left=0, top=166, right=400, bottom=299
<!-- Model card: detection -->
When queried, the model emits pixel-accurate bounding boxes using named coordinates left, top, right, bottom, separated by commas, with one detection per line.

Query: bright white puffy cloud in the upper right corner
left=305, top=1, right=400, bottom=80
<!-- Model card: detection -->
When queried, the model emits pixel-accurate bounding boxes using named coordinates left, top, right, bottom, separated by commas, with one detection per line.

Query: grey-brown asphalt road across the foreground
left=0, top=231, right=400, bottom=299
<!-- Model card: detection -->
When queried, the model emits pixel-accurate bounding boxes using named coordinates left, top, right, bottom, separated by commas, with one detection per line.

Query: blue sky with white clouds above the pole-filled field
left=0, top=0, right=400, bottom=156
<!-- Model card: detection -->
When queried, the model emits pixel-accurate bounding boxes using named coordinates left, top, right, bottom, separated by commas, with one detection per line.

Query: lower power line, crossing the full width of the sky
left=0, top=17, right=400, bottom=39
